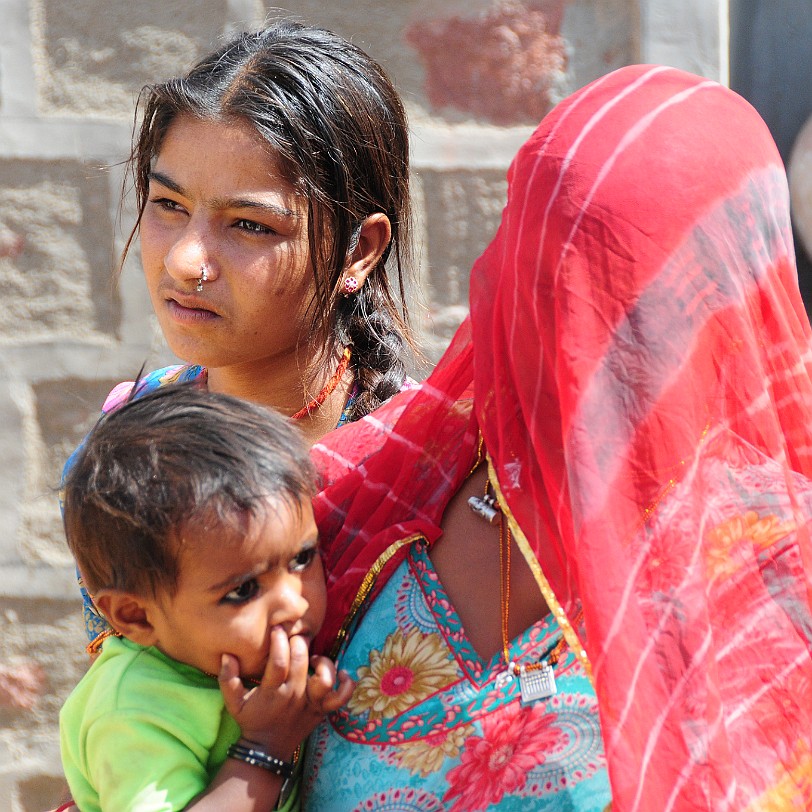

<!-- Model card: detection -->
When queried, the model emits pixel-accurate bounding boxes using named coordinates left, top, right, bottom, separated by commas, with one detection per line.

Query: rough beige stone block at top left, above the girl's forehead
left=32, top=0, right=227, bottom=119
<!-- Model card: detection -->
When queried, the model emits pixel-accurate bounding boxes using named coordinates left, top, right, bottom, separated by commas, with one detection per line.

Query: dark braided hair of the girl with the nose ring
left=124, top=21, right=414, bottom=419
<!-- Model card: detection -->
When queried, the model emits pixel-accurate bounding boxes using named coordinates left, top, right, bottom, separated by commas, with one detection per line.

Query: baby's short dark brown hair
left=63, top=384, right=315, bottom=597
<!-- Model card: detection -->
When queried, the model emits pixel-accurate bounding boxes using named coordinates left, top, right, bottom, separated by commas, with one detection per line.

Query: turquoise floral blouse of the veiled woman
left=303, top=539, right=611, bottom=812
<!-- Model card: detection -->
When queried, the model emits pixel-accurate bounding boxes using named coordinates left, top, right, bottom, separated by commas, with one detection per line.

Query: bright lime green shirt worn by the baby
left=59, top=637, right=298, bottom=812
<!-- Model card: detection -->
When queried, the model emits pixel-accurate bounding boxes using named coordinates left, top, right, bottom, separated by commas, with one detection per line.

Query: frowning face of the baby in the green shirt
left=144, top=500, right=327, bottom=679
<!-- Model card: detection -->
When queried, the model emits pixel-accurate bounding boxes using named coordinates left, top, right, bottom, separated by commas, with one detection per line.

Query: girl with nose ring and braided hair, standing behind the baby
left=68, top=22, right=412, bottom=646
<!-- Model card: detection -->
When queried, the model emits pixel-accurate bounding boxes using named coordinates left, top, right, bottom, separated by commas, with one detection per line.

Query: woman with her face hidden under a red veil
left=305, top=66, right=812, bottom=812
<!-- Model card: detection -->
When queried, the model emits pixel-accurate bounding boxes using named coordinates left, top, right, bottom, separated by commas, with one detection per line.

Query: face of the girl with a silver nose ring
left=140, top=116, right=314, bottom=372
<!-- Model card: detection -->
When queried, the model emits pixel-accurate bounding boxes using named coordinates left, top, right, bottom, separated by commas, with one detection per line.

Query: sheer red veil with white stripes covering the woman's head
left=314, top=66, right=812, bottom=812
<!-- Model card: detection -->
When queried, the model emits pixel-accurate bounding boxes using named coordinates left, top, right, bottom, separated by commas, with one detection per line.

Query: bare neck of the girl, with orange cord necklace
left=208, top=359, right=353, bottom=445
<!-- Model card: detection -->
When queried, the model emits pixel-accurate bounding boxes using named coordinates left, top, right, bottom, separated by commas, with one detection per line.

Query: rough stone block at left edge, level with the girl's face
left=0, top=160, right=118, bottom=344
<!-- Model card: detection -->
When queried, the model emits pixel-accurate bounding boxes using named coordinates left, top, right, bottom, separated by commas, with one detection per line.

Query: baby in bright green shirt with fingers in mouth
left=60, top=384, right=353, bottom=812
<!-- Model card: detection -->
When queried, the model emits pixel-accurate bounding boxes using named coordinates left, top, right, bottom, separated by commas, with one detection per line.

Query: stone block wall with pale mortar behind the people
left=0, top=0, right=725, bottom=812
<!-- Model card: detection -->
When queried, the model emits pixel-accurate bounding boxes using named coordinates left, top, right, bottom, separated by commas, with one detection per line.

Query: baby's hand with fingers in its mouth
left=219, top=628, right=354, bottom=760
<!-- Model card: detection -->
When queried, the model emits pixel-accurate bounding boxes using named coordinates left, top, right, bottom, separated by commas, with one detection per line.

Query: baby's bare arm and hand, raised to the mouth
left=186, top=628, right=354, bottom=812
